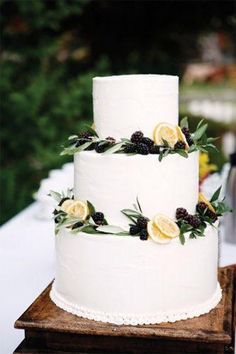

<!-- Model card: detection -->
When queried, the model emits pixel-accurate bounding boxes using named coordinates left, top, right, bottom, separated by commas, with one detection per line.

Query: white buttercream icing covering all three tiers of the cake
left=50, top=75, right=221, bottom=325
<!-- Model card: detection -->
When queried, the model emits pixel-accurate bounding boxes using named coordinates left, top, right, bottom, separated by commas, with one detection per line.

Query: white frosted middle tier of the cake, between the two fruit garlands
left=74, top=151, right=198, bottom=227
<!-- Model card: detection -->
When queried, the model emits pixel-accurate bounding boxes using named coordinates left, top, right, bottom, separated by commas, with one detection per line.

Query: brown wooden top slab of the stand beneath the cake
left=15, top=267, right=234, bottom=344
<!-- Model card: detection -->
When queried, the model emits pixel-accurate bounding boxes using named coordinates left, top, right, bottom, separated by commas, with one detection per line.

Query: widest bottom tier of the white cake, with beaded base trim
left=50, top=226, right=221, bottom=325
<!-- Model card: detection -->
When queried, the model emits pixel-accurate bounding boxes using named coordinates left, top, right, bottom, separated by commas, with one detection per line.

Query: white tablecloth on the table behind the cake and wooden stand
left=0, top=202, right=236, bottom=354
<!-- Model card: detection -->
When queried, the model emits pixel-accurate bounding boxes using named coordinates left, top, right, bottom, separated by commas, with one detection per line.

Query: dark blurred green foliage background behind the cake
left=0, top=0, right=236, bottom=223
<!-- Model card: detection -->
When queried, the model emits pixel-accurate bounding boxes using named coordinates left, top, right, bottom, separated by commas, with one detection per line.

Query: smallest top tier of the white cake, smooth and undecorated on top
left=93, top=75, right=179, bottom=139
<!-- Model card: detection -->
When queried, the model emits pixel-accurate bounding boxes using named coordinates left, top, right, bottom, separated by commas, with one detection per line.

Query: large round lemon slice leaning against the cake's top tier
left=153, top=123, right=178, bottom=147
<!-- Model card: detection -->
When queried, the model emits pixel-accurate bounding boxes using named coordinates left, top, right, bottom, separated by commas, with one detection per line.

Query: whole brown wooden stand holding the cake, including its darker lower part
left=14, top=267, right=235, bottom=354
